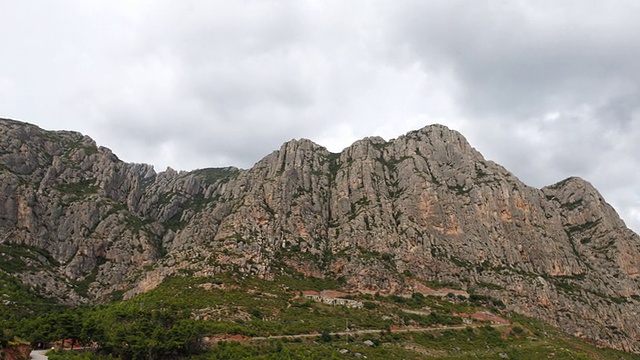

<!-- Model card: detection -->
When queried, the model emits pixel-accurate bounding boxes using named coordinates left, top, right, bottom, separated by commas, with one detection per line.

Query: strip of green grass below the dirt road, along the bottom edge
left=42, top=323, right=639, bottom=360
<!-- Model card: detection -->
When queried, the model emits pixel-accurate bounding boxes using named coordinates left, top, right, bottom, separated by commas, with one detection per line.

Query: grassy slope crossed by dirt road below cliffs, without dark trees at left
left=2, top=275, right=640, bottom=360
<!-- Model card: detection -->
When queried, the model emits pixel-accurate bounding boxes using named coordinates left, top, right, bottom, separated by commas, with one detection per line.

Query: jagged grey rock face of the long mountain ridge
left=0, top=120, right=640, bottom=352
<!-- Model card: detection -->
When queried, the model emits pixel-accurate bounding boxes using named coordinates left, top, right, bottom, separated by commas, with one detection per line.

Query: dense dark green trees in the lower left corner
left=2, top=307, right=211, bottom=359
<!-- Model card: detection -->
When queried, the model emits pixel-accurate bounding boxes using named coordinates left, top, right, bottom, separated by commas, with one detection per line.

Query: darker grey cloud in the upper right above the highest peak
left=392, top=1, right=640, bottom=117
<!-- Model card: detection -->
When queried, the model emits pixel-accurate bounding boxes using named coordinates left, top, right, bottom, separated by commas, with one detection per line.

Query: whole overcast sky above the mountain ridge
left=0, top=0, right=640, bottom=232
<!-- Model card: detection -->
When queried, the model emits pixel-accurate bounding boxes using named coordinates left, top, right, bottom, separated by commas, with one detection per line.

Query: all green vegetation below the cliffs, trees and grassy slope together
left=0, top=273, right=640, bottom=360
